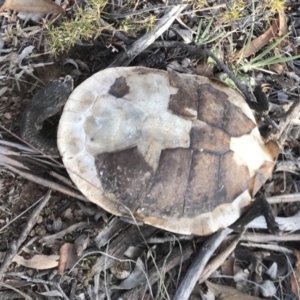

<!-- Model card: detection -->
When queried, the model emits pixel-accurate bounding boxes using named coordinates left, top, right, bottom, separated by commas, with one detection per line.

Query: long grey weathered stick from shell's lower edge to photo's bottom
left=173, top=228, right=232, bottom=300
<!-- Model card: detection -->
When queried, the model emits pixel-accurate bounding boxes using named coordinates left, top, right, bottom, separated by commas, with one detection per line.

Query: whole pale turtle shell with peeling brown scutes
left=57, top=67, right=278, bottom=235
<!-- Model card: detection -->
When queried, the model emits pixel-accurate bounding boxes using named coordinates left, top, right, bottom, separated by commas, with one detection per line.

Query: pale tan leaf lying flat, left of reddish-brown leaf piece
left=13, top=254, right=59, bottom=270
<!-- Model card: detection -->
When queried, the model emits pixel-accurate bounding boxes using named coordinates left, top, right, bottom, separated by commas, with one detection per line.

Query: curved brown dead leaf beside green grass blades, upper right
left=234, top=22, right=278, bottom=59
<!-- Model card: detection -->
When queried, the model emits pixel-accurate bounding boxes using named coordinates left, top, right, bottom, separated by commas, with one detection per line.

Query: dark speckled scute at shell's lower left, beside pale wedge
left=95, top=147, right=153, bottom=214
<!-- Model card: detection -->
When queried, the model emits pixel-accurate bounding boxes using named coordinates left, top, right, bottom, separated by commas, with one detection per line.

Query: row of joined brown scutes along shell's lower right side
left=141, top=149, right=250, bottom=218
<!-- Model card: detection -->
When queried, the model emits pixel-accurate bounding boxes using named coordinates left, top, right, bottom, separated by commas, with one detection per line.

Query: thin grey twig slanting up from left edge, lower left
left=0, top=190, right=51, bottom=280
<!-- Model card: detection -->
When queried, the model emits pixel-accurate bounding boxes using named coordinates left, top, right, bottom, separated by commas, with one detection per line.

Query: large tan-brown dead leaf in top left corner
left=0, top=0, right=64, bottom=14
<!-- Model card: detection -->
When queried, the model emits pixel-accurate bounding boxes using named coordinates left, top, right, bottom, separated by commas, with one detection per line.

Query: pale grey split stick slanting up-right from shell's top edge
left=108, top=4, right=187, bottom=68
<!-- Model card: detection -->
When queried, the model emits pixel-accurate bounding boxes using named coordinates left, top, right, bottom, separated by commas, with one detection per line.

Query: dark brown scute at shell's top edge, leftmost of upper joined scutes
left=168, top=71, right=199, bottom=119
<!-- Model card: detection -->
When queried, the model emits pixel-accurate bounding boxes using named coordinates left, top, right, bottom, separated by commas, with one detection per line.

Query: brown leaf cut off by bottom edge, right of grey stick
left=205, top=281, right=262, bottom=300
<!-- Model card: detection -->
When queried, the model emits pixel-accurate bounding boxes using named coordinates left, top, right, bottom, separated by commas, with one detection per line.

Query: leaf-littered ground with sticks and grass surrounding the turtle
left=0, top=0, right=300, bottom=299
